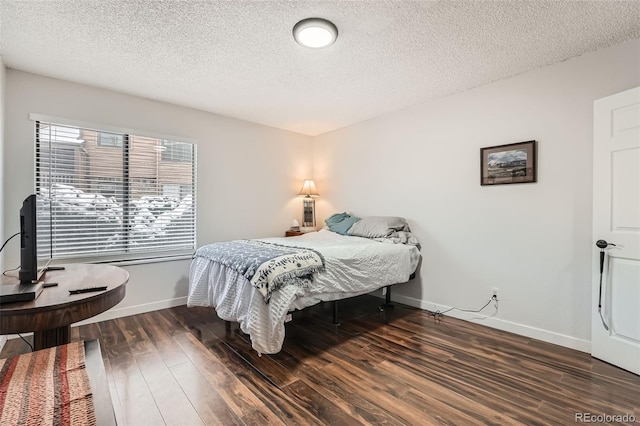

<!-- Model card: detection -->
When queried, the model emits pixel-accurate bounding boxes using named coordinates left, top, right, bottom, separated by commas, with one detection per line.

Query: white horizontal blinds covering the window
left=36, top=121, right=196, bottom=261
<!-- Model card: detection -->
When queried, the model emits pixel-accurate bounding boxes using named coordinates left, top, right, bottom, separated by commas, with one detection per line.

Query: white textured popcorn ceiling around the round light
left=0, top=0, right=640, bottom=135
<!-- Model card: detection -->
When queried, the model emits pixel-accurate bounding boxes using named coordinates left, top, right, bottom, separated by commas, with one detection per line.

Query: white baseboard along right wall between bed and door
left=384, top=292, right=591, bottom=353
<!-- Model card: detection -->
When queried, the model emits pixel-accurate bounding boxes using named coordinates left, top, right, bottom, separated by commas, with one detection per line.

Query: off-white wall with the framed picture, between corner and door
left=314, top=40, right=640, bottom=351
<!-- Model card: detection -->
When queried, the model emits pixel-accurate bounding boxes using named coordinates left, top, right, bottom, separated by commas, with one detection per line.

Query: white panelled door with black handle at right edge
left=591, top=87, right=640, bottom=375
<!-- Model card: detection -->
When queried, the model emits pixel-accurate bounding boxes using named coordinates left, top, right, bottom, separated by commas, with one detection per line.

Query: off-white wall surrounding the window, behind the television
left=1, top=69, right=312, bottom=319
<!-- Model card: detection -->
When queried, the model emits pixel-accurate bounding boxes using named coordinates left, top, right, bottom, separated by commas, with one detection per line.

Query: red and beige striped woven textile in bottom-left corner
left=0, top=342, right=96, bottom=426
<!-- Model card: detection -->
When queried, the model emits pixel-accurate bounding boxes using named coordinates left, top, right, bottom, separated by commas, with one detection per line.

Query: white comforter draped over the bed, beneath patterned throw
left=187, top=230, right=420, bottom=354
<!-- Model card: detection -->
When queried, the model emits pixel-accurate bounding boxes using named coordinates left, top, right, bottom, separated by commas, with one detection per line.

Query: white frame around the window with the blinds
left=29, top=113, right=197, bottom=265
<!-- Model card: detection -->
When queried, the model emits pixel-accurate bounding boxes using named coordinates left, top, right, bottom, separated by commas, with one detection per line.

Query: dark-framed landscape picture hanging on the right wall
left=480, top=141, right=537, bottom=185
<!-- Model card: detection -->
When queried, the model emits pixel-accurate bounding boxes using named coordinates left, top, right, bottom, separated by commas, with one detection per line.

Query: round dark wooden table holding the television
left=0, top=263, right=129, bottom=350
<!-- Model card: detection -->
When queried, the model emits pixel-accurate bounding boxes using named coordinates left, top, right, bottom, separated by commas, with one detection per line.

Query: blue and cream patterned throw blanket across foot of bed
left=195, top=240, right=324, bottom=303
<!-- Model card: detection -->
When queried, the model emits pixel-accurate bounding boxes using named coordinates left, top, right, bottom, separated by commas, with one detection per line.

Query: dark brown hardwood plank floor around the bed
left=0, top=296, right=640, bottom=425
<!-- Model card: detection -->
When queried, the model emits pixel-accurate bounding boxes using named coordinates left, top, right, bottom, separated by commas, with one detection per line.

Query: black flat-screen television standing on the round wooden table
left=18, top=194, right=38, bottom=284
